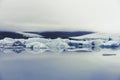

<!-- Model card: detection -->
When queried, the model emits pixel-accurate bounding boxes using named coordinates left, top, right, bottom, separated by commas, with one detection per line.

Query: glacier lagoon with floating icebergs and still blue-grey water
left=0, top=33, right=120, bottom=80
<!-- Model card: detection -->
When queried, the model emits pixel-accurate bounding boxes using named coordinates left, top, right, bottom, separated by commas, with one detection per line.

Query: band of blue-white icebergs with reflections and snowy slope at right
left=0, top=33, right=120, bottom=53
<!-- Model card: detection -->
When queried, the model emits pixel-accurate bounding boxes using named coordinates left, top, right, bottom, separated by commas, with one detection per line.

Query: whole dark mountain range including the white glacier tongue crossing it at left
left=0, top=31, right=94, bottom=39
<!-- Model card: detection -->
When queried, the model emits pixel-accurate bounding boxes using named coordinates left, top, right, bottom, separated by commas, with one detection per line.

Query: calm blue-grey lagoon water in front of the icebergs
left=0, top=50, right=120, bottom=80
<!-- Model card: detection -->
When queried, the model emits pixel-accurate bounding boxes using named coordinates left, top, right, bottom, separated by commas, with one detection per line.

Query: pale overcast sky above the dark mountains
left=0, top=0, right=120, bottom=33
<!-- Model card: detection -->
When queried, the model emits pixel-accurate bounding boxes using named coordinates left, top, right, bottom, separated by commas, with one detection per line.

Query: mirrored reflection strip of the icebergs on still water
left=0, top=47, right=101, bottom=53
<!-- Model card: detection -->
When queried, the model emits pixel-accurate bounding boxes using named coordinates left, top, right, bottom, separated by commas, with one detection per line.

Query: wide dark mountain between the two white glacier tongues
left=27, top=31, right=94, bottom=39
